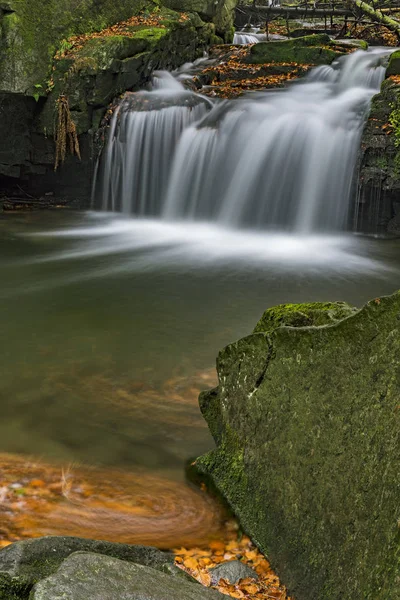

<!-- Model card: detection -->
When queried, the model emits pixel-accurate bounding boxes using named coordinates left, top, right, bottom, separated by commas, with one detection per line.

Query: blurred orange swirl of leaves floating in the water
left=0, top=454, right=223, bottom=548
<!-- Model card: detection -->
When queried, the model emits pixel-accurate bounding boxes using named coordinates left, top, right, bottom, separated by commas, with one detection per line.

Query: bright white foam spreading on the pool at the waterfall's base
left=26, top=213, right=386, bottom=281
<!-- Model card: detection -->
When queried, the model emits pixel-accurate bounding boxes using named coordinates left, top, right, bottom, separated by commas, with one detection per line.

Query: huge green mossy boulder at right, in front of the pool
left=197, top=292, right=400, bottom=600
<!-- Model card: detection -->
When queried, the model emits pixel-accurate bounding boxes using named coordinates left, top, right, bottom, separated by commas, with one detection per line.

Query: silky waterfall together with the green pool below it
left=0, top=50, right=400, bottom=488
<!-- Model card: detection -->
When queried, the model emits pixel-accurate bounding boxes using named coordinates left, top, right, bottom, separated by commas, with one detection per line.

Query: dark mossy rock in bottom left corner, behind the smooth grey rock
left=0, top=536, right=176, bottom=600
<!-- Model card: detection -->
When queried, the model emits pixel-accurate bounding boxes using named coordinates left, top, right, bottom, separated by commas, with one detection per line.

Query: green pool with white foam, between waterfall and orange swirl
left=0, top=212, right=400, bottom=480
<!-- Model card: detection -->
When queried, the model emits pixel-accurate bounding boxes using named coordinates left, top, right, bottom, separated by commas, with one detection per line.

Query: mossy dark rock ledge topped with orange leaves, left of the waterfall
left=37, top=9, right=214, bottom=135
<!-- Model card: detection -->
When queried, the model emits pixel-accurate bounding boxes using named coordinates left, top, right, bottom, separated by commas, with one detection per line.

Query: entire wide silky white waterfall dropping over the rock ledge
left=95, top=49, right=387, bottom=233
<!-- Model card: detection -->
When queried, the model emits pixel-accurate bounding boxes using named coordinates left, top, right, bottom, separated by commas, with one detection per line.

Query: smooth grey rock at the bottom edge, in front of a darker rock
left=31, top=552, right=224, bottom=600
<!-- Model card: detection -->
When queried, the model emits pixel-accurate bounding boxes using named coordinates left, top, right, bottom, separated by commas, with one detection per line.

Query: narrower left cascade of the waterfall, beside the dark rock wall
left=101, top=72, right=210, bottom=215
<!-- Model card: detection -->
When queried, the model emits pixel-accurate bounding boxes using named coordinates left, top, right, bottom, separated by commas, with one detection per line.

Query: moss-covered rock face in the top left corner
left=0, top=0, right=155, bottom=95
